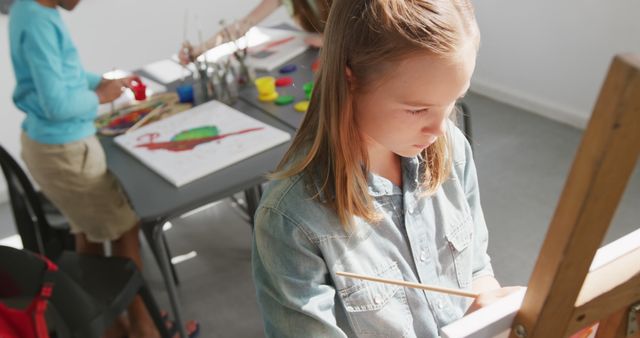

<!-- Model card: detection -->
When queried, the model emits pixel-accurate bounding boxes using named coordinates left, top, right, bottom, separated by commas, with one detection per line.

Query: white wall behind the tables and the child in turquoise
left=0, top=0, right=288, bottom=203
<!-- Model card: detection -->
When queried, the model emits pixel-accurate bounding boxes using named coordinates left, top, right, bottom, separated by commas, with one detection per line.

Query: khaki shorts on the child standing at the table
left=21, top=133, right=138, bottom=242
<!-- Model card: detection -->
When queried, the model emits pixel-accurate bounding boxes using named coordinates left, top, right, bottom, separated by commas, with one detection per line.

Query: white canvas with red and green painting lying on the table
left=115, top=101, right=291, bottom=187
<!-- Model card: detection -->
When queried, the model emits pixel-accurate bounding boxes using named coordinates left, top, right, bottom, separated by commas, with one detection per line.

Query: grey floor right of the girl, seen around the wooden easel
left=465, top=95, right=640, bottom=285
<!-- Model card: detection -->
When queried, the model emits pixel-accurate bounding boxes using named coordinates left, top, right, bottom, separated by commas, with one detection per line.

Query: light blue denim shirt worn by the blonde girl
left=252, top=127, right=493, bottom=338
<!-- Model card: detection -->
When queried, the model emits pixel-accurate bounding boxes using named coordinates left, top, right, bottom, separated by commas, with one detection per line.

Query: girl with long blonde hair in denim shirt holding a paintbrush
left=252, top=0, right=519, bottom=337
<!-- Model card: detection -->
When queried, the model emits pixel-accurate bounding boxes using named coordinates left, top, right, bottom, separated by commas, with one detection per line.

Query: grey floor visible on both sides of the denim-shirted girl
left=0, top=94, right=640, bottom=337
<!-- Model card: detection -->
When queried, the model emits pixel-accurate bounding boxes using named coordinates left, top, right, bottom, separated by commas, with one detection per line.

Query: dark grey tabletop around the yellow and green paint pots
left=240, top=48, right=319, bottom=130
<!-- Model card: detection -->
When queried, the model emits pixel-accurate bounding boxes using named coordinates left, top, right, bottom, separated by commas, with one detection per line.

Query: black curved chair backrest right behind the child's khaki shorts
left=0, top=146, right=63, bottom=259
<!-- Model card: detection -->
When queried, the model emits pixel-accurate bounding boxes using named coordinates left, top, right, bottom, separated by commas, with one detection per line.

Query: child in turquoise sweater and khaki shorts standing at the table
left=9, top=0, right=197, bottom=338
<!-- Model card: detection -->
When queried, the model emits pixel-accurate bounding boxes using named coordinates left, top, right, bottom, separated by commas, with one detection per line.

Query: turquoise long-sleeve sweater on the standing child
left=9, top=0, right=101, bottom=144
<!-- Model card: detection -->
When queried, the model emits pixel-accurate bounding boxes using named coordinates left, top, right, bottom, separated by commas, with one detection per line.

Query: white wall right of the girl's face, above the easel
left=472, top=0, right=640, bottom=128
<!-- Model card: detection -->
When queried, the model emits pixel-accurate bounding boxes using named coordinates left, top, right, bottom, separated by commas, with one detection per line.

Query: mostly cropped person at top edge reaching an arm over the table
left=178, top=0, right=331, bottom=64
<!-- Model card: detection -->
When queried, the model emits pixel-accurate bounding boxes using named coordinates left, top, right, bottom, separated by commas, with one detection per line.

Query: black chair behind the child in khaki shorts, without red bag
left=0, top=146, right=74, bottom=259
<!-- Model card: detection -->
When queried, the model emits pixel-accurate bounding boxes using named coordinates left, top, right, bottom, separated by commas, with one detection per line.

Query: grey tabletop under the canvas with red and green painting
left=100, top=100, right=293, bottom=223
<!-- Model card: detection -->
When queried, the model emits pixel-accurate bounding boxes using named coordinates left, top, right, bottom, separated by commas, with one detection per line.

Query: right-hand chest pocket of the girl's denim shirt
left=445, top=219, right=473, bottom=289
